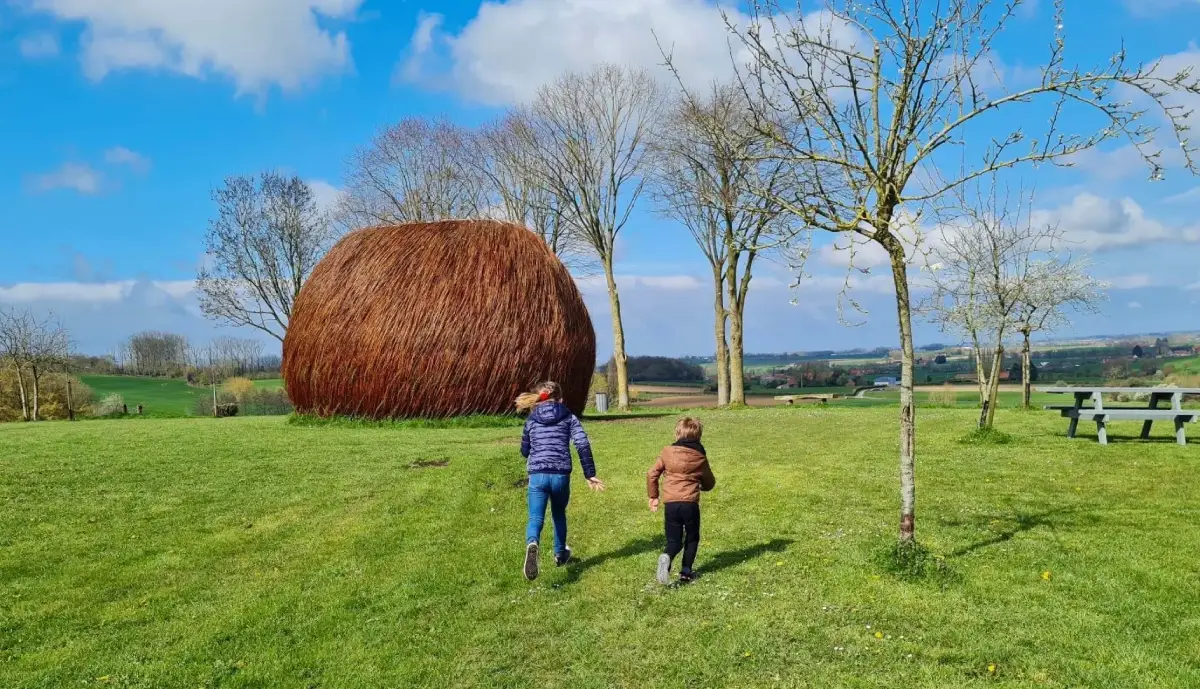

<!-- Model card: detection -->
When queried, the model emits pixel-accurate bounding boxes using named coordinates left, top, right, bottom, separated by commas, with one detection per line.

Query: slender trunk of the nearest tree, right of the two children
left=884, top=246, right=917, bottom=544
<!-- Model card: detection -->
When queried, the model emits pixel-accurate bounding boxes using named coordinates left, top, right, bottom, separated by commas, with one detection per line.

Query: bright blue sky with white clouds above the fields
left=0, top=0, right=1200, bottom=355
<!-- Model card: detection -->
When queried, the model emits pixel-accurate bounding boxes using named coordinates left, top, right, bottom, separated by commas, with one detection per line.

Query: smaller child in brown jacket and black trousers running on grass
left=646, top=417, right=716, bottom=586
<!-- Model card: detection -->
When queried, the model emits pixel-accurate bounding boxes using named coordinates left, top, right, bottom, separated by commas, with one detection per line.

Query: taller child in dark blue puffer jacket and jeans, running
left=517, top=381, right=605, bottom=581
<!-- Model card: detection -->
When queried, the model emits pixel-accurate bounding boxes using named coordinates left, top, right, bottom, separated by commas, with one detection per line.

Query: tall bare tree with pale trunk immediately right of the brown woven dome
left=521, top=65, right=666, bottom=409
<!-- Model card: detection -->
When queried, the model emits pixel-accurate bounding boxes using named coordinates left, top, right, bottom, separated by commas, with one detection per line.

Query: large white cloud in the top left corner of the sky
left=31, top=0, right=362, bottom=94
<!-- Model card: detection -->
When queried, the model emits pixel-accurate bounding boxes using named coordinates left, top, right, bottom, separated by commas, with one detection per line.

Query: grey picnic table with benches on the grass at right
left=1038, top=387, right=1200, bottom=445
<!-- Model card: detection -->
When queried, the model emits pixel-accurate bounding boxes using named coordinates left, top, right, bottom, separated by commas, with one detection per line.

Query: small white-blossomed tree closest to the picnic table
left=1016, top=254, right=1109, bottom=409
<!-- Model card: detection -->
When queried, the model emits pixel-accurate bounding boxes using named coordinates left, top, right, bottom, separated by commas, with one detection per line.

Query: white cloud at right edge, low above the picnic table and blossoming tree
left=1032, top=193, right=1200, bottom=251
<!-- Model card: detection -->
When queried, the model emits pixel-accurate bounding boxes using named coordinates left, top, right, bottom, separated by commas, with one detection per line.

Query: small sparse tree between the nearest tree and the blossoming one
left=928, top=186, right=1062, bottom=427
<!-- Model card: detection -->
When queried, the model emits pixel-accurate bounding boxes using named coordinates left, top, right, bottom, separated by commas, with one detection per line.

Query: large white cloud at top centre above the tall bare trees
left=397, top=0, right=857, bottom=104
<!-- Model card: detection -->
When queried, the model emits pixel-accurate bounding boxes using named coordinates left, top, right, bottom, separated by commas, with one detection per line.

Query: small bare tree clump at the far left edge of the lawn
left=0, top=310, right=71, bottom=421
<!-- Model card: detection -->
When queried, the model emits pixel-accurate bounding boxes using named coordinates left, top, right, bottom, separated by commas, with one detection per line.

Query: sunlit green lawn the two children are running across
left=0, top=408, right=1200, bottom=689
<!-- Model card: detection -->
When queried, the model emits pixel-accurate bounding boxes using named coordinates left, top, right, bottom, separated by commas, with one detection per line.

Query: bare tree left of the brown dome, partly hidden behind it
left=197, top=173, right=336, bottom=341
